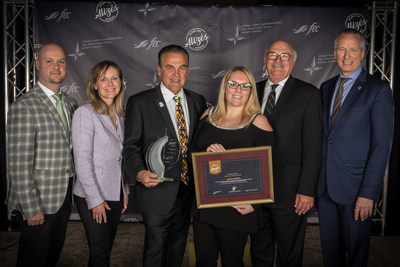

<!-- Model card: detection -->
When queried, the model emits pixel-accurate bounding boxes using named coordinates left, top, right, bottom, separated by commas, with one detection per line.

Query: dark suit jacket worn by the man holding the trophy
left=122, top=86, right=206, bottom=215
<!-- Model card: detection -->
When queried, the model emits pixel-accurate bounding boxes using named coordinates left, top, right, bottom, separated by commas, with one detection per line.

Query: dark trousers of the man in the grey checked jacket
left=17, top=179, right=72, bottom=267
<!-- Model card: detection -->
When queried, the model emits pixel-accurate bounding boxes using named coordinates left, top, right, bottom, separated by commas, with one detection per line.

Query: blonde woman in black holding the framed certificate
left=191, top=66, right=273, bottom=267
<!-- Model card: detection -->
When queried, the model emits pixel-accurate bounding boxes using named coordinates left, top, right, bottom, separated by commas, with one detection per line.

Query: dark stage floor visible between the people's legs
left=0, top=221, right=400, bottom=267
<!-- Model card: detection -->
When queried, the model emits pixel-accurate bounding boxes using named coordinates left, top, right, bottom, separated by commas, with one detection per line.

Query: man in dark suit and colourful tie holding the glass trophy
left=123, top=45, right=206, bottom=267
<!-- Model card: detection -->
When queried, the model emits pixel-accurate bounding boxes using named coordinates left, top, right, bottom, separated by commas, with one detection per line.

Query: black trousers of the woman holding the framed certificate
left=193, top=218, right=249, bottom=267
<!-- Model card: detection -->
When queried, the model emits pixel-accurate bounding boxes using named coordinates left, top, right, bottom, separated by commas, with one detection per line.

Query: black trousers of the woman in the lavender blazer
left=74, top=195, right=123, bottom=267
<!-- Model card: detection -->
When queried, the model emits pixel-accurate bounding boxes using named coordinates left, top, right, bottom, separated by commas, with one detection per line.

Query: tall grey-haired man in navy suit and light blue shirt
left=317, top=29, right=394, bottom=267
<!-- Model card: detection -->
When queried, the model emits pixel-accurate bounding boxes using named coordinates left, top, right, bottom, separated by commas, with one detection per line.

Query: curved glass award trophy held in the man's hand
left=146, top=129, right=180, bottom=181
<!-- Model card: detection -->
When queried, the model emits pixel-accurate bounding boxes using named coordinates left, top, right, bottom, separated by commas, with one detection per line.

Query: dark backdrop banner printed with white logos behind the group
left=34, top=0, right=367, bottom=221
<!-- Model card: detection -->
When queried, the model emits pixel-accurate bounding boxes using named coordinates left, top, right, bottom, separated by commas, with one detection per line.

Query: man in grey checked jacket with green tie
left=7, top=43, right=78, bottom=266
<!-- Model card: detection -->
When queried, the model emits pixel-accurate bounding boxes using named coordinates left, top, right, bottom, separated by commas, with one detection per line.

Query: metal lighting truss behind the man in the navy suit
left=367, top=1, right=398, bottom=235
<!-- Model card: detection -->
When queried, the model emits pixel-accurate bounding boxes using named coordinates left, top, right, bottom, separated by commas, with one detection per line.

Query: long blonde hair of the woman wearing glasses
left=209, top=66, right=261, bottom=124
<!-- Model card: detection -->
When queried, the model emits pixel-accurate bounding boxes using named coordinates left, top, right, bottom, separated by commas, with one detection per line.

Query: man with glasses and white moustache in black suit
left=251, top=40, right=321, bottom=267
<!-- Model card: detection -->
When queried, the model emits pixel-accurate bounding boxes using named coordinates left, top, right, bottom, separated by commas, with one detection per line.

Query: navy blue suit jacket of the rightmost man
left=318, top=70, right=394, bottom=205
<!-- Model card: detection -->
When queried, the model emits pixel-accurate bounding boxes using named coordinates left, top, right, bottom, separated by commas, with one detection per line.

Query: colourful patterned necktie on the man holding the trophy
left=174, top=96, right=189, bottom=185
